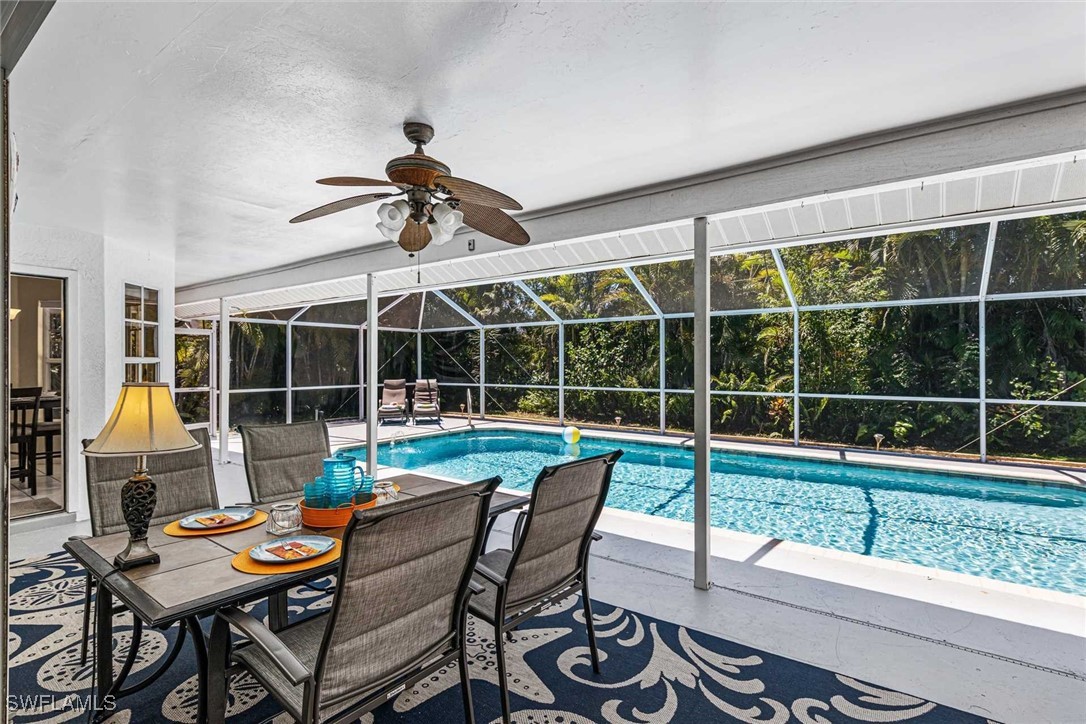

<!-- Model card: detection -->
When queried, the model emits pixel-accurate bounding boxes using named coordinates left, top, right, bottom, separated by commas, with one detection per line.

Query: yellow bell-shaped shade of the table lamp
left=84, top=382, right=200, bottom=456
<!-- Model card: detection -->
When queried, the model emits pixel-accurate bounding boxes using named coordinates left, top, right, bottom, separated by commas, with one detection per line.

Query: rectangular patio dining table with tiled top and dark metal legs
left=64, top=473, right=529, bottom=722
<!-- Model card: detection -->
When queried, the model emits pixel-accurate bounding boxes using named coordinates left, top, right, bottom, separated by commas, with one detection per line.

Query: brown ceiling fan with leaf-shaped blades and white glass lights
left=290, top=123, right=530, bottom=253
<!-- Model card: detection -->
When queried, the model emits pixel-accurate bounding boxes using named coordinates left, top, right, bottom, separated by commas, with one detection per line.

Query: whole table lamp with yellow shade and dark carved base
left=83, top=382, right=200, bottom=571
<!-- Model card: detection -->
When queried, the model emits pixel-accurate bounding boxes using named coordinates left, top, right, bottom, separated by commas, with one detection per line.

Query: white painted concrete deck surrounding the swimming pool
left=11, top=418, right=1086, bottom=722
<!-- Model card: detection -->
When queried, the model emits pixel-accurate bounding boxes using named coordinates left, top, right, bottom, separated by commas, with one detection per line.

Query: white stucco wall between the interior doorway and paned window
left=11, top=221, right=174, bottom=520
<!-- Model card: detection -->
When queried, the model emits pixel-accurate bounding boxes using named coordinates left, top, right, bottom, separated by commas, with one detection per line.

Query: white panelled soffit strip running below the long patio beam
left=174, top=151, right=1086, bottom=319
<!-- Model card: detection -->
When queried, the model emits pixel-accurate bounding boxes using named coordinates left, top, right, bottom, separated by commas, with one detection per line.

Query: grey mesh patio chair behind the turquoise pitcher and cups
left=241, top=420, right=331, bottom=503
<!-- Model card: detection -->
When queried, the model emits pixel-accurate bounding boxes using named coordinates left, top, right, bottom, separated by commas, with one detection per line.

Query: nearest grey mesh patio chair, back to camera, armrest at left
left=207, top=478, right=502, bottom=724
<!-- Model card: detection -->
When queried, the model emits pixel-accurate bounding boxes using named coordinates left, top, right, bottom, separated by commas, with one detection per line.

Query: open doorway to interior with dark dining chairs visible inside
left=8, top=274, right=70, bottom=519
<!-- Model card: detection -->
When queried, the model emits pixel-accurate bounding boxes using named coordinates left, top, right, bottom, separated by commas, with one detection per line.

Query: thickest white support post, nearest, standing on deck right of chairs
left=694, top=216, right=711, bottom=590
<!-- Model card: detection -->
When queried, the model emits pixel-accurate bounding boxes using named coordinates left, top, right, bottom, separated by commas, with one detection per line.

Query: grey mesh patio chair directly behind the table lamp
left=77, top=428, right=219, bottom=664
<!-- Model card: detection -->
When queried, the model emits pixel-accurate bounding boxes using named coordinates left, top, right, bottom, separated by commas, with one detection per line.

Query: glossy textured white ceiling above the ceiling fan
left=11, top=2, right=1086, bottom=285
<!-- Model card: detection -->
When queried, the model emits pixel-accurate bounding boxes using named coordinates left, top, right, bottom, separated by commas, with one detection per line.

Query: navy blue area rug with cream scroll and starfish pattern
left=9, top=554, right=984, bottom=724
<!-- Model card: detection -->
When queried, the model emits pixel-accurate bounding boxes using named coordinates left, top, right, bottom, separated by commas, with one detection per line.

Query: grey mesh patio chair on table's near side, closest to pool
left=469, top=450, right=622, bottom=724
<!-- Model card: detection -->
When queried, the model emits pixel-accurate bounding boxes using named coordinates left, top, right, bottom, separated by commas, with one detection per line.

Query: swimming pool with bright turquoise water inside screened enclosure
left=349, top=430, right=1086, bottom=595
